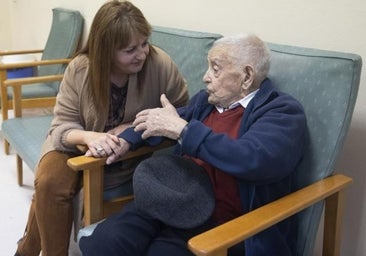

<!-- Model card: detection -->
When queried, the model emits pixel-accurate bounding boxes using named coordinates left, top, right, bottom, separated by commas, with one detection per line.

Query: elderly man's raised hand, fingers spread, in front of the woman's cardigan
left=133, top=94, right=187, bottom=140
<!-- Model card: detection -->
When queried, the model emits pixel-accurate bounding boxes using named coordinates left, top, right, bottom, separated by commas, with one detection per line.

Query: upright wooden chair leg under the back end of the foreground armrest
left=323, top=190, right=345, bottom=256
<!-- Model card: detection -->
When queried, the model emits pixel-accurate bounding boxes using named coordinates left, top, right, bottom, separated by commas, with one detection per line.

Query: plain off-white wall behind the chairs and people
left=0, top=0, right=366, bottom=256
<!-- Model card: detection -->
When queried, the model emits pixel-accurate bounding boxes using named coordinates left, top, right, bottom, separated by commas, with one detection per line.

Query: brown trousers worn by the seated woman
left=17, top=151, right=80, bottom=256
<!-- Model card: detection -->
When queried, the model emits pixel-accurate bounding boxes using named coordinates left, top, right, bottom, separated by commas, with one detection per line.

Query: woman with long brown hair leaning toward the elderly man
left=16, top=1, right=188, bottom=256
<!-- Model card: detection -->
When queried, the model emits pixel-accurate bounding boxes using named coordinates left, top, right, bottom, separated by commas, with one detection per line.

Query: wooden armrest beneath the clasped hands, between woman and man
left=67, top=140, right=176, bottom=171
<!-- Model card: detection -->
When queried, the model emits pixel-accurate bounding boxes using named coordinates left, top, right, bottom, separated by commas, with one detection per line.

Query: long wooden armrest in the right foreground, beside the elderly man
left=188, top=174, right=352, bottom=256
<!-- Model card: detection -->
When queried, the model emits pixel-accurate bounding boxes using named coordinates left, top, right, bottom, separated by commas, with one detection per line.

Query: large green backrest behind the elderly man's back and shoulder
left=269, top=43, right=362, bottom=256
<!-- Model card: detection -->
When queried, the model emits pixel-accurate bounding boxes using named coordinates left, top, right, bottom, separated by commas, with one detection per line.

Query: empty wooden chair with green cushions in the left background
left=0, top=8, right=84, bottom=154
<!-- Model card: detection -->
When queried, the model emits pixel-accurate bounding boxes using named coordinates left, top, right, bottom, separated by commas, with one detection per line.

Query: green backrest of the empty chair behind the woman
left=38, top=8, right=84, bottom=91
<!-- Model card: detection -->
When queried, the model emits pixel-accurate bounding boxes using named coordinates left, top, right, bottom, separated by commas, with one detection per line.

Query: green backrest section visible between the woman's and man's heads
left=150, top=26, right=222, bottom=97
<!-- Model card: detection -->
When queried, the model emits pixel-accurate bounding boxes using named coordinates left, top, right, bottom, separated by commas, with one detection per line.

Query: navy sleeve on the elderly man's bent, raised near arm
left=181, top=95, right=306, bottom=184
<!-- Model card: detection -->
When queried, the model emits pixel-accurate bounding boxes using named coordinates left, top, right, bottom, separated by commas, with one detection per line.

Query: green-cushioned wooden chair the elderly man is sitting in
left=69, top=29, right=362, bottom=256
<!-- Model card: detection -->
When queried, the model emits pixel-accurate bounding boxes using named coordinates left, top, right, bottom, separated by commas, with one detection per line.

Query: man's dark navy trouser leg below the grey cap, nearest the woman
left=79, top=202, right=161, bottom=256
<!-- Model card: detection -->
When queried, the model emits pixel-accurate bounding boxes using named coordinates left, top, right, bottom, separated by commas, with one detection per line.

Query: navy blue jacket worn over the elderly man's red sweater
left=120, top=79, right=307, bottom=256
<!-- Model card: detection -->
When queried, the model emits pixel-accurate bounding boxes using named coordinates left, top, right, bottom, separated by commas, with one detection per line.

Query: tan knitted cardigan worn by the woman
left=41, top=47, right=188, bottom=159
